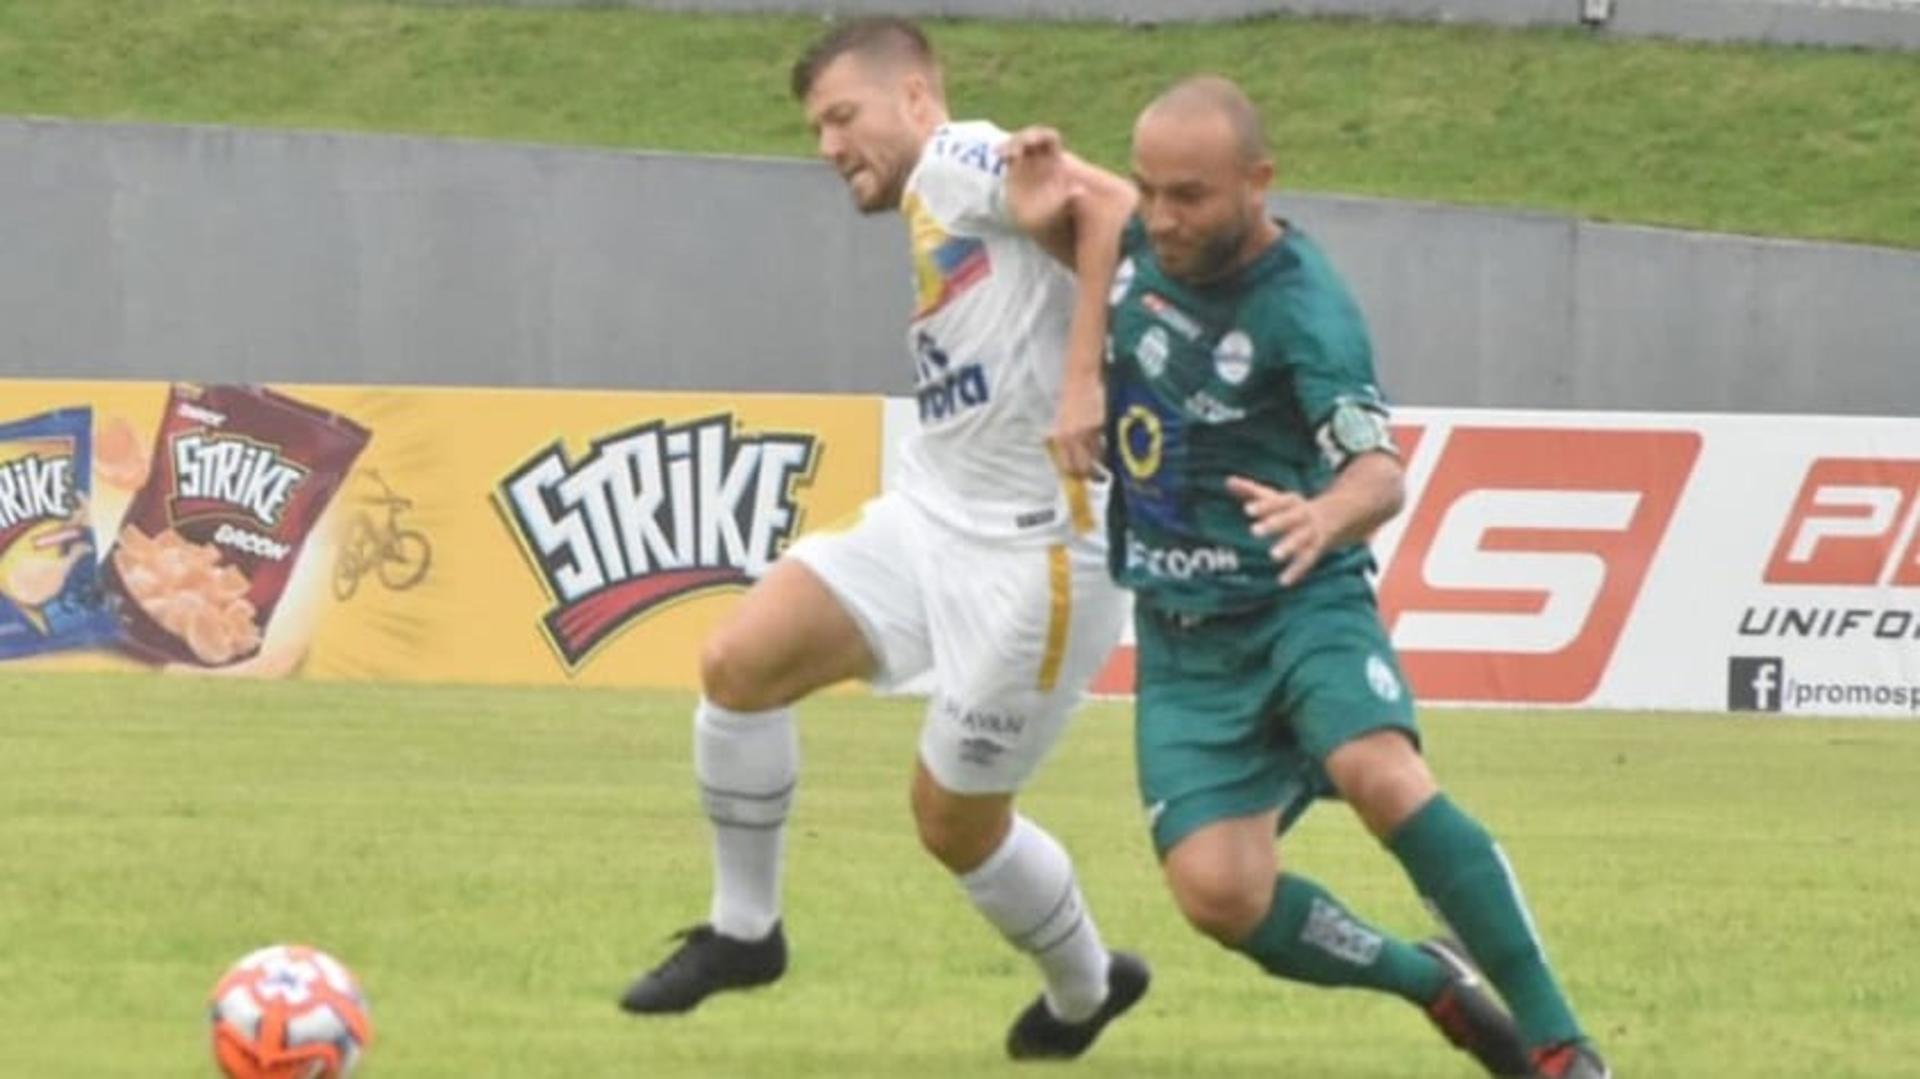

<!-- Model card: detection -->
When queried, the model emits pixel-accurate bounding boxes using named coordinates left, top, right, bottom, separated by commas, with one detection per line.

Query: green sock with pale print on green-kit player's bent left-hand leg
left=1240, top=874, right=1446, bottom=1004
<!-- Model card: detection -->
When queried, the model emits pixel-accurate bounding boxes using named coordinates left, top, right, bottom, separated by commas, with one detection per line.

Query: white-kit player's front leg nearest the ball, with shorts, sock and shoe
left=622, top=501, right=924, bottom=1014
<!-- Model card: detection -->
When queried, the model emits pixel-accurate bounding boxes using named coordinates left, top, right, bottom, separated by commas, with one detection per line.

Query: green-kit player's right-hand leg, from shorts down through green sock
left=1281, top=591, right=1605, bottom=1073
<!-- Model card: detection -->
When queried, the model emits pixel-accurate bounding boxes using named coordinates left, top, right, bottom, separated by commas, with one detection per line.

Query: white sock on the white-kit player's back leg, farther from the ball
left=960, top=814, right=1110, bottom=1023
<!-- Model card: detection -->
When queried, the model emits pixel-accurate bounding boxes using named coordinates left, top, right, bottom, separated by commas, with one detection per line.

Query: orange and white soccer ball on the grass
left=209, top=945, right=372, bottom=1079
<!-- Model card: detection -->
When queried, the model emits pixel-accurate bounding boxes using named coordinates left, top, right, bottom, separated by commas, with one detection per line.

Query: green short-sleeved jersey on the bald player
left=1106, top=219, right=1392, bottom=614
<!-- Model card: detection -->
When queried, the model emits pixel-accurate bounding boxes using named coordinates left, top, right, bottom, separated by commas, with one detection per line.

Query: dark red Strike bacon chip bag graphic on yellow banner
left=102, top=378, right=369, bottom=668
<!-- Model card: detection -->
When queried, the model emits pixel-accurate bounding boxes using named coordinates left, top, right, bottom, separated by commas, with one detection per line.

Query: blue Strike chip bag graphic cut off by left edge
left=0, top=409, right=117, bottom=659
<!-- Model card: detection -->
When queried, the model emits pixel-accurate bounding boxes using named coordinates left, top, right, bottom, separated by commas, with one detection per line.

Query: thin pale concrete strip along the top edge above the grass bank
left=428, top=0, right=1920, bottom=48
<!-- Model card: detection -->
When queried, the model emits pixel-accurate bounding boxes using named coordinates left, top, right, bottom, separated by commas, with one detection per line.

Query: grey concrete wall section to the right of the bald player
left=1277, top=196, right=1920, bottom=415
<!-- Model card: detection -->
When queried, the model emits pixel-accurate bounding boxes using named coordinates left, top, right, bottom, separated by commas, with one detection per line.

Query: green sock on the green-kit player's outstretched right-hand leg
left=1386, top=795, right=1582, bottom=1048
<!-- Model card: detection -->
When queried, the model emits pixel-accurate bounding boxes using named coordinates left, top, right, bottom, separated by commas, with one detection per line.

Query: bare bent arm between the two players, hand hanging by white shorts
left=1000, top=127, right=1137, bottom=478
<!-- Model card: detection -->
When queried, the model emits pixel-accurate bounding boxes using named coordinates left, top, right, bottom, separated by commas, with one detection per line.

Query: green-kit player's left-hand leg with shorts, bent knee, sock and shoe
left=1135, top=599, right=1526, bottom=1075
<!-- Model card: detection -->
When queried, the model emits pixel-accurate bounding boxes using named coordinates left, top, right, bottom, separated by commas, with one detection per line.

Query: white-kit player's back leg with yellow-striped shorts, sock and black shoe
left=912, top=533, right=1150, bottom=1058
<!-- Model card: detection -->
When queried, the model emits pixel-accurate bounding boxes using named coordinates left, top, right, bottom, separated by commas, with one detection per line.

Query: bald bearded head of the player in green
left=1133, top=109, right=1269, bottom=282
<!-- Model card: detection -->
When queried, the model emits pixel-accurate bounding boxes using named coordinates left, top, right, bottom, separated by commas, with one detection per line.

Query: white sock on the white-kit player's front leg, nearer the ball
left=693, top=697, right=801, bottom=941
